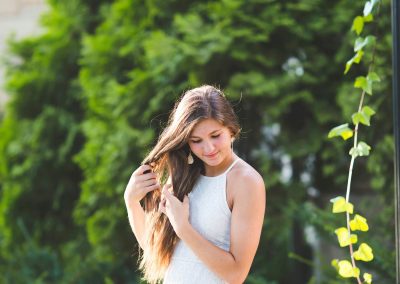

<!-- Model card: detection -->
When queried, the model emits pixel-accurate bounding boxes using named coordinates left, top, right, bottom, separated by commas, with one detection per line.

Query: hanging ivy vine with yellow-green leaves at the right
left=328, top=0, right=381, bottom=284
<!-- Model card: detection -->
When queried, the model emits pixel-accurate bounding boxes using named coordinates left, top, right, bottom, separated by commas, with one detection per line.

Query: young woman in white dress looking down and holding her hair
left=124, top=86, right=265, bottom=284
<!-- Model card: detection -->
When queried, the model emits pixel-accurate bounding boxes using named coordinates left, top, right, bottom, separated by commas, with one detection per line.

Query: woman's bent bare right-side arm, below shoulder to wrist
left=161, top=171, right=265, bottom=284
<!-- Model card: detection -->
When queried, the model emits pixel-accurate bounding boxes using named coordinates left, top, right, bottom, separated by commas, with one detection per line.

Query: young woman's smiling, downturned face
left=188, top=118, right=232, bottom=166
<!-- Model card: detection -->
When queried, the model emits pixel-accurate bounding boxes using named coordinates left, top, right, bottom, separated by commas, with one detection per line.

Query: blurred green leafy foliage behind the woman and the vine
left=0, top=0, right=396, bottom=284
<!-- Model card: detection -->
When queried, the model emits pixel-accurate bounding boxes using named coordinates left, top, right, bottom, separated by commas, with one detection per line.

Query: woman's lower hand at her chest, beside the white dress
left=158, top=185, right=189, bottom=238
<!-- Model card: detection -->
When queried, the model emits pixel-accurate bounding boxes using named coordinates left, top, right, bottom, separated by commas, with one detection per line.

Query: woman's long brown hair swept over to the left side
left=140, top=85, right=240, bottom=283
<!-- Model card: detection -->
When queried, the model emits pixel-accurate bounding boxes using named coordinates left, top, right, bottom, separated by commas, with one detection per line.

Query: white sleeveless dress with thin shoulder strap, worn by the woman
left=163, top=158, right=239, bottom=284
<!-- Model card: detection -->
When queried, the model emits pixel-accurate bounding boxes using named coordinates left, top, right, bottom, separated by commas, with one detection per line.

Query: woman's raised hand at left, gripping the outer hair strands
left=124, top=165, right=161, bottom=205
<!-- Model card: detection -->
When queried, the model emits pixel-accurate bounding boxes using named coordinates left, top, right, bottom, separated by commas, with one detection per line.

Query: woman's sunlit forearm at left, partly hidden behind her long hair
left=126, top=202, right=145, bottom=249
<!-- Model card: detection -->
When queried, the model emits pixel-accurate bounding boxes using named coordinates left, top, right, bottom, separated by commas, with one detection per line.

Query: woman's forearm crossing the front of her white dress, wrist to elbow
left=180, top=224, right=248, bottom=284
